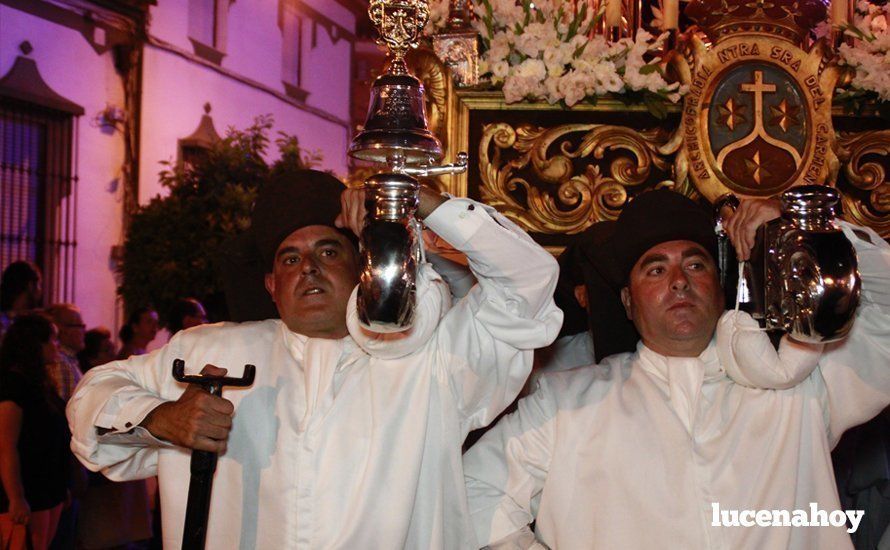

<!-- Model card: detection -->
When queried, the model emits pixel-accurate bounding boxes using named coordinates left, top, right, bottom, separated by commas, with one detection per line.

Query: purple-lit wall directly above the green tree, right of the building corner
left=139, top=0, right=356, bottom=203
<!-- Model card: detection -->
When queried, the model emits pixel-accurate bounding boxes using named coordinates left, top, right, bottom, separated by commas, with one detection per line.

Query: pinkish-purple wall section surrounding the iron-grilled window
left=0, top=5, right=124, bottom=327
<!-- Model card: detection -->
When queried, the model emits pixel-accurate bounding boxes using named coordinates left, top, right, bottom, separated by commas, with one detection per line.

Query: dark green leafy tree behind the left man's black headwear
left=118, top=116, right=321, bottom=323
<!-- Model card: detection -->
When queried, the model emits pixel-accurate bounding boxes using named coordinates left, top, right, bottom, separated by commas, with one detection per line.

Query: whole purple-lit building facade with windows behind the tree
left=0, top=0, right=366, bottom=334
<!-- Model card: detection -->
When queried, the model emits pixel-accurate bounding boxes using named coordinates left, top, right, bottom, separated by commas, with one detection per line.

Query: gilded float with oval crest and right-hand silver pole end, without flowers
left=418, top=0, right=868, bottom=342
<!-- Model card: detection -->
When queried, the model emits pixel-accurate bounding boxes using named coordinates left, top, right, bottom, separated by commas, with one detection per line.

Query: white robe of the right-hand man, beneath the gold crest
left=464, top=222, right=890, bottom=550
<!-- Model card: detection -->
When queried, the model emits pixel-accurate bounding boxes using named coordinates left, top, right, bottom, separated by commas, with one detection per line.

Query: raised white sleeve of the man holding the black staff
left=424, top=198, right=562, bottom=432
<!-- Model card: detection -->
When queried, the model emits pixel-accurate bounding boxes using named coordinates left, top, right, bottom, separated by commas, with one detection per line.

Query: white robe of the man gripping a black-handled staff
left=68, top=199, right=562, bottom=550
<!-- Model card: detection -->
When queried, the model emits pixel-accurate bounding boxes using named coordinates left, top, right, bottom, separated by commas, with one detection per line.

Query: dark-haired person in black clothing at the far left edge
left=0, top=314, right=71, bottom=550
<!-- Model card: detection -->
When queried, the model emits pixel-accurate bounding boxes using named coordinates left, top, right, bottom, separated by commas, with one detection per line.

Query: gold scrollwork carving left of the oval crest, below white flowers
left=479, top=122, right=671, bottom=234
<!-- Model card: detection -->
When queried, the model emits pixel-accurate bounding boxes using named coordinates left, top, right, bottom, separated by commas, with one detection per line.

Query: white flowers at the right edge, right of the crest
left=837, top=0, right=890, bottom=114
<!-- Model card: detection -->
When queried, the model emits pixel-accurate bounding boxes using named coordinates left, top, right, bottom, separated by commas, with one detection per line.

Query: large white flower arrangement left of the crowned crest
left=428, top=0, right=686, bottom=117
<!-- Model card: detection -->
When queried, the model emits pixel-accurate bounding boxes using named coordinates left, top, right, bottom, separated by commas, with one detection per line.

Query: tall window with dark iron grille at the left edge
left=0, top=98, right=78, bottom=303
